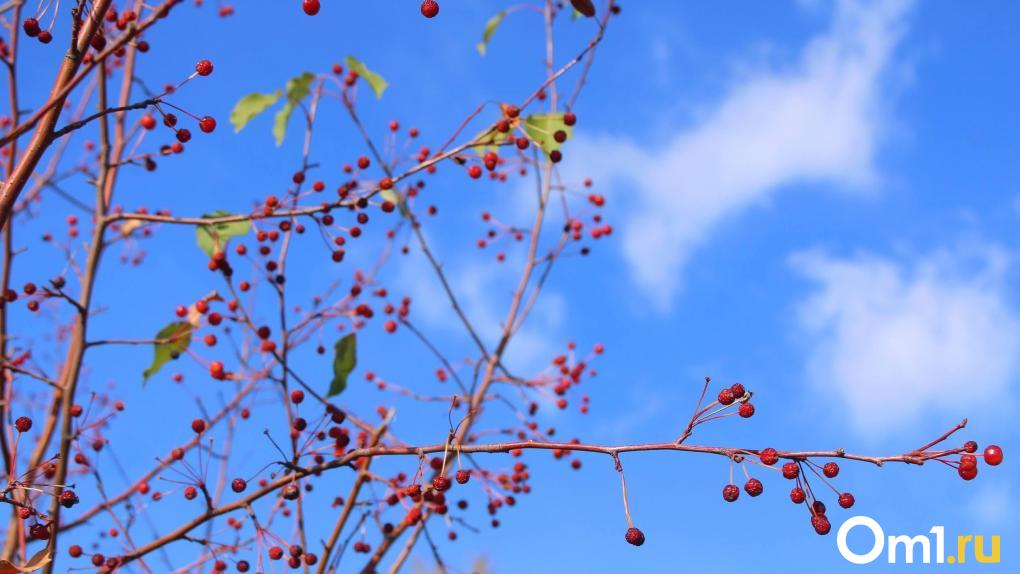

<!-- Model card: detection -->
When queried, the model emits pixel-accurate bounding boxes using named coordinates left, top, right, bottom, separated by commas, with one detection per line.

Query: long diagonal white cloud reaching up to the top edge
left=571, top=0, right=909, bottom=307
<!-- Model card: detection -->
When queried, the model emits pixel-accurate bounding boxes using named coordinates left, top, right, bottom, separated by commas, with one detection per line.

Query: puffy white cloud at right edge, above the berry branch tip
left=792, top=245, right=1020, bottom=435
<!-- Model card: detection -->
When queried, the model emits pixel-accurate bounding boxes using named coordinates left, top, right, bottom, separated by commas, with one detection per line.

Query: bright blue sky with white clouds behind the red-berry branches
left=7, top=0, right=1020, bottom=573
